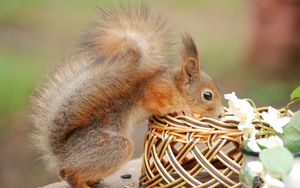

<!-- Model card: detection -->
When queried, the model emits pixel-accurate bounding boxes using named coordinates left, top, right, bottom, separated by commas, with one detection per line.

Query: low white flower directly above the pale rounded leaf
left=247, top=136, right=283, bottom=152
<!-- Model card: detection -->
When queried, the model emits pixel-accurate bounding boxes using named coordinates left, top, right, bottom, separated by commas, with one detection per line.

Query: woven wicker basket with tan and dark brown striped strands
left=139, top=108, right=278, bottom=188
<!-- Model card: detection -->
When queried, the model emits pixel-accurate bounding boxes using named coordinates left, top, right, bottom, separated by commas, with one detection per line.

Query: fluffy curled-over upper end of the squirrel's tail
left=81, top=6, right=171, bottom=63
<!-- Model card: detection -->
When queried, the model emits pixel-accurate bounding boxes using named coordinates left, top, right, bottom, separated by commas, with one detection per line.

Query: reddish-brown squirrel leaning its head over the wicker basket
left=31, top=6, right=223, bottom=188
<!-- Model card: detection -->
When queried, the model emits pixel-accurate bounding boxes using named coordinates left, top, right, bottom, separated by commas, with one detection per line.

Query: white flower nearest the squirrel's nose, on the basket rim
left=224, top=92, right=255, bottom=127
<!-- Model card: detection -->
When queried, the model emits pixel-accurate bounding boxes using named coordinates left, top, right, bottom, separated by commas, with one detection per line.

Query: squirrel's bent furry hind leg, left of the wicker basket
left=60, top=131, right=133, bottom=188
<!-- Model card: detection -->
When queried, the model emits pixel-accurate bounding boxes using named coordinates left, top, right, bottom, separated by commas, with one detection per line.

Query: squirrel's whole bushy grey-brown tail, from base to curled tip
left=32, top=6, right=171, bottom=170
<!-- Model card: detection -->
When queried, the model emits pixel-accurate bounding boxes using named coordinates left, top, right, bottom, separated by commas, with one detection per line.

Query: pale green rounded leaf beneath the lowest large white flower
left=259, top=147, right=294, bottom=178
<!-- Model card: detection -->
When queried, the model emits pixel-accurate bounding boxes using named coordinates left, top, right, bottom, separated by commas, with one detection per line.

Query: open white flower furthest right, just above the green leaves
left=261, top=106, right=290, bottom=133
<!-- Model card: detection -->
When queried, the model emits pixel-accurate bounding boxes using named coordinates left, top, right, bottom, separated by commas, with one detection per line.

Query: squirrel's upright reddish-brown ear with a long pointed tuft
left=181, top=34, right=200, bottom=81
